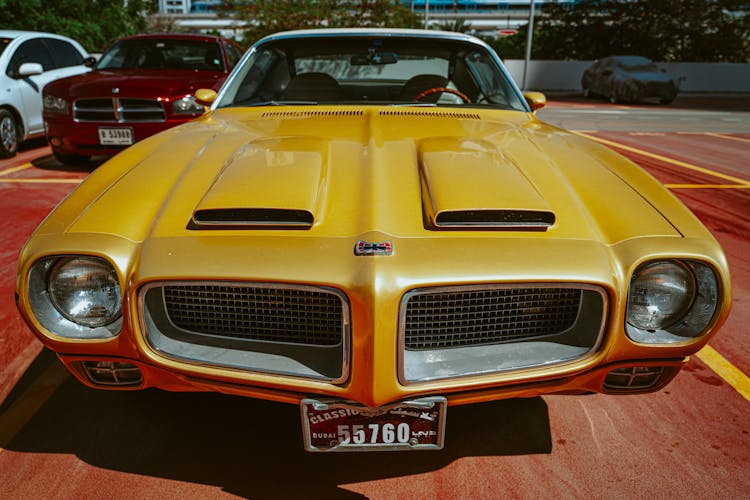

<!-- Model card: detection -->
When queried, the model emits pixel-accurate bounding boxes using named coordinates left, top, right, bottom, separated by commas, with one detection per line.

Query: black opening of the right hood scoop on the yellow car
left=435, top=210, right=555, bottom=231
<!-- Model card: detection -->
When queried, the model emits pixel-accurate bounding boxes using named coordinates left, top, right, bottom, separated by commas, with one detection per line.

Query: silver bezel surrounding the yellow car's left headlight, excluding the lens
left=27, top=254, right=124, bottom=340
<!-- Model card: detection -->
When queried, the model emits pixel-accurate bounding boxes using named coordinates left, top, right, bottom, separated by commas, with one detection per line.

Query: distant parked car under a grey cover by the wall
left=581, top=56, right=679, bottom=104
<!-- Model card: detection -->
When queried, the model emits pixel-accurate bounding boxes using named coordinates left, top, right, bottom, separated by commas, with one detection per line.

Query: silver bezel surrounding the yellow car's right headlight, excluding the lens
left=624, top=258, right=724, bottom=346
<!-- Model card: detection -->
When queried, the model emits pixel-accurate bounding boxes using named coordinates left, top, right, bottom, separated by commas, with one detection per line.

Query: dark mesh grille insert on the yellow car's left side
left=163, top=284, right=344, bottom=346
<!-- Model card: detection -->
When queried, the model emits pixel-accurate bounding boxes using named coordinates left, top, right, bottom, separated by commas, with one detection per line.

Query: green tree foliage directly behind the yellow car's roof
left=222, top=0, right=421, bottom=46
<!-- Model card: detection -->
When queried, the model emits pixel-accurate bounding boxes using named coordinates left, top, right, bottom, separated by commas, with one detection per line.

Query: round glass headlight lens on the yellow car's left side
left=47, top=257, right=121, bottom=328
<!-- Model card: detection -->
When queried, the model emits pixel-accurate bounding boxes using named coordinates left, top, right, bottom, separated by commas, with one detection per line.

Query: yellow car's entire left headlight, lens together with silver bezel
left=29, top=255, right=122, bottom=339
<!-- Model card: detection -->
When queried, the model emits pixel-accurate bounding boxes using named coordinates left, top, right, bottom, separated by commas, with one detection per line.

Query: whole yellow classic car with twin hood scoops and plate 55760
left=16, top=30, right=731, bottom=451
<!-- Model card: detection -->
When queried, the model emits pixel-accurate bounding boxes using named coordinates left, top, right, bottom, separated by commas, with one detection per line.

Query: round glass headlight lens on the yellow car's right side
left=627, top=260, right=696, bottom=331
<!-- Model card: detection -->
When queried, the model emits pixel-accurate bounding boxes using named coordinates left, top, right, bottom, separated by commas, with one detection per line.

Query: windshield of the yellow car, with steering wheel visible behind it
left=217, top=36, right=526, bottom=111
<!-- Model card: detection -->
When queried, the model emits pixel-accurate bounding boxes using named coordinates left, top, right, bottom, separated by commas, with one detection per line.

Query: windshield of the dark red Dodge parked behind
left=96, top=39, right=224, bottom=71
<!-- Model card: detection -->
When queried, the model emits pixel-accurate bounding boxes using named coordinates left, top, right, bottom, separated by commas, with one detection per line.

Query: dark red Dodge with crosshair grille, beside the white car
left=43, top=33, right=242, bottom=164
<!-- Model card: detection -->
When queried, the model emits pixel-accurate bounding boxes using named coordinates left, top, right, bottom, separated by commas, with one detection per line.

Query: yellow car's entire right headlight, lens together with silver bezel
left=626, top=260, right=719, bottom=344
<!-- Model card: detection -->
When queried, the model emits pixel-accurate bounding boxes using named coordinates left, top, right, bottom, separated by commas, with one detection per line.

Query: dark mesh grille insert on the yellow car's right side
left=402, top=287, right=582, bottom=350
